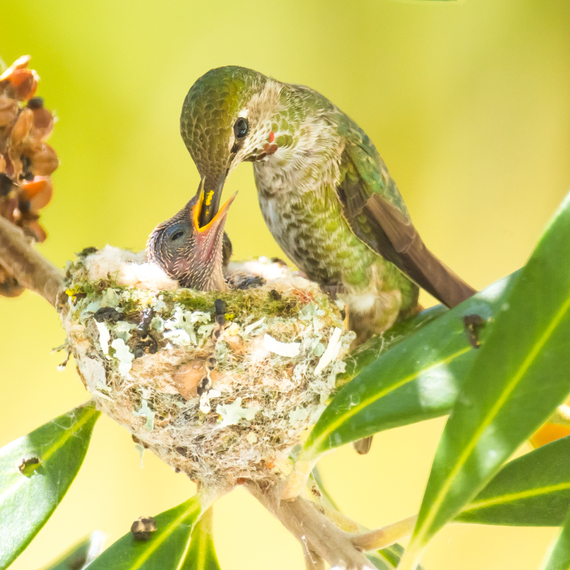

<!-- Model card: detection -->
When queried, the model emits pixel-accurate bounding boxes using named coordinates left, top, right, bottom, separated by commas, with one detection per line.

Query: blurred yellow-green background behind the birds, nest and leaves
left=0, top=0, right=570, bottom=570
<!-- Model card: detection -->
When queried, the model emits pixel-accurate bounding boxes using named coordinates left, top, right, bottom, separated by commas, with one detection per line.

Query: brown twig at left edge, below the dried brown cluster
left=0, top=216, right=63, bottom=307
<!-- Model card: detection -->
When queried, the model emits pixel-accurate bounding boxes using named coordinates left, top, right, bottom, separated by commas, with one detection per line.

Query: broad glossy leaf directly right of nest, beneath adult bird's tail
left=299, top=275, right=514, bottom=463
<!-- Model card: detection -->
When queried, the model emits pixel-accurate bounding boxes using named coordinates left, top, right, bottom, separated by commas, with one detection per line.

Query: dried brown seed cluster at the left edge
left=0, top=56, right=59, bottom=297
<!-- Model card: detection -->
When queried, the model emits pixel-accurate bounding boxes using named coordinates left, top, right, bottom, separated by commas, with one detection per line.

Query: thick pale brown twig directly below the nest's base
left=246, top=481, right=374, bottom=570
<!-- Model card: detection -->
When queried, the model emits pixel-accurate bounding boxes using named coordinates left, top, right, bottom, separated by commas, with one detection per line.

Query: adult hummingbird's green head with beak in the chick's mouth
left=180, top=66, right=286, bottom=225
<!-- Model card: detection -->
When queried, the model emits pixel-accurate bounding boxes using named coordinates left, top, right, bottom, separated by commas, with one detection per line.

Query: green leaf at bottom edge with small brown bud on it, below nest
left=89, top=496, right=203, bottom=570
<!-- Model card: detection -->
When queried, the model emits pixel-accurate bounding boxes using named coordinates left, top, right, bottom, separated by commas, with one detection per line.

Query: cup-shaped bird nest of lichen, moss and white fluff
left=58, top=246, right=354, bottom=488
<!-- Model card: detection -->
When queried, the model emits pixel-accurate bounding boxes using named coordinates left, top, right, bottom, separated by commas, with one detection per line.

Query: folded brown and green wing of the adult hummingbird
left=337, top=117, right=476, bottom=307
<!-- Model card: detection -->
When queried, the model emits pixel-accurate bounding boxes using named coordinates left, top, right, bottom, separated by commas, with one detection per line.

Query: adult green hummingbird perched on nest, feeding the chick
left=180, top=66, right=476, bottom=343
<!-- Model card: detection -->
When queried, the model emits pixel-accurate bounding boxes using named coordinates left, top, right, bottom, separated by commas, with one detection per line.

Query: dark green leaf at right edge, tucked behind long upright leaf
left=455, top=436, right=570, bottom=526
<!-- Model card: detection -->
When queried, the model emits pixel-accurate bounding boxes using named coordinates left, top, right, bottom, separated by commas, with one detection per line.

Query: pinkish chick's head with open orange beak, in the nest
left=147, top=179, right=235, bottom=291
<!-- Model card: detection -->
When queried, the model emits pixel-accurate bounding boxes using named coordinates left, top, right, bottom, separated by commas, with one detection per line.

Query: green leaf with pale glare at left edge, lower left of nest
left=0, top=404, right=99, bottom=570
